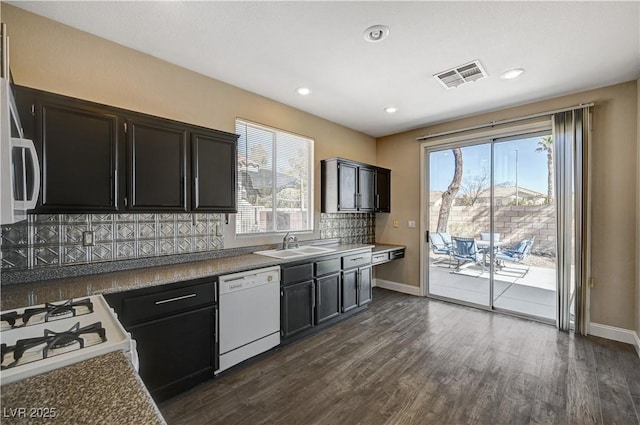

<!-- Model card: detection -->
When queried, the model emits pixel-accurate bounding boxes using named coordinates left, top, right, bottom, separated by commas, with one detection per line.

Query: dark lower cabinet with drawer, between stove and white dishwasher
left=105, top=278, right=218, bottom=401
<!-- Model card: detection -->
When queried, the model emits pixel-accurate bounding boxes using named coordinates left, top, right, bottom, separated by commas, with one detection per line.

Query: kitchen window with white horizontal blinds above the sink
left=236, top=120, right=313, bottom=235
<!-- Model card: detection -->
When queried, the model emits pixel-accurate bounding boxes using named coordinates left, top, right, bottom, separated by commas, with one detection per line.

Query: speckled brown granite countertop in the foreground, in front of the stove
left=0, top=351, right=166, bottom=425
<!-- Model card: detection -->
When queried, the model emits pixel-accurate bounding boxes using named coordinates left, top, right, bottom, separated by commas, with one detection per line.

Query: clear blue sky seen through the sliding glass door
left=430, top=136, right=547, bottom=194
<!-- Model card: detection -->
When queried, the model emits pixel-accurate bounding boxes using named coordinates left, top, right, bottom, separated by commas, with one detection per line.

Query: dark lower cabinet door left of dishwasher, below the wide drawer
left=127, top=307, right=216, bottom=401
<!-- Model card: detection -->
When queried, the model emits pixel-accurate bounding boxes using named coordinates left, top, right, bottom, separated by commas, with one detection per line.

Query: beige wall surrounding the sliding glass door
left=376, top=81, right=640, bottom=329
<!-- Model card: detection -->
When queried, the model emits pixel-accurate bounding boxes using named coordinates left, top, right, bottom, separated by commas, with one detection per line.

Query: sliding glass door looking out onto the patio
left=425, top=132, right=557, bottom=322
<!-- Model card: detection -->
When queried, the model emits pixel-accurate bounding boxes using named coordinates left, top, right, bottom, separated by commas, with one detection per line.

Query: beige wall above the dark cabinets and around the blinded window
left=0, top=3, right=376, bottom=247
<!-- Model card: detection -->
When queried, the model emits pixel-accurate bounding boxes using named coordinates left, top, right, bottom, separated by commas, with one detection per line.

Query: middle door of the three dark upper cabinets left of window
left=127, top=119, right=188, bottom=211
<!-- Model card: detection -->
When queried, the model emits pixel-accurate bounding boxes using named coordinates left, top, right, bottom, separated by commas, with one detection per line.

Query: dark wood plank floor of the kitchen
left=160, top=288, right=640, bottom=425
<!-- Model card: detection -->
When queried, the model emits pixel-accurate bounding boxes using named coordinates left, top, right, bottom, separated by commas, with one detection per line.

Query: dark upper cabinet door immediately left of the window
left=191, top=132, right=237, bottom=213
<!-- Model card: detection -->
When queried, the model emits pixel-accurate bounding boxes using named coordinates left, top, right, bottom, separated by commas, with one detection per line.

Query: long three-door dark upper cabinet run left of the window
left=14, top=86, right=238, bottom=213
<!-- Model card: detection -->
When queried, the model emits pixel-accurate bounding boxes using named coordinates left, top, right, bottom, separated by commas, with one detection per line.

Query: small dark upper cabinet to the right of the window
left=320, top=158, right=391, bottom=213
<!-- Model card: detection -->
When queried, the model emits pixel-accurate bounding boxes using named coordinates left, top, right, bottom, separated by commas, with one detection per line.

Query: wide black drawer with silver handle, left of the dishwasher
left=122, top=282, right=216, bottom=325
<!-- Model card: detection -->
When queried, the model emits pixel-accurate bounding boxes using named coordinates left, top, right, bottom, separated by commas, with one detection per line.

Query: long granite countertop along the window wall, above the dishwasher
left=0, top=244, right=384, bottom=311
